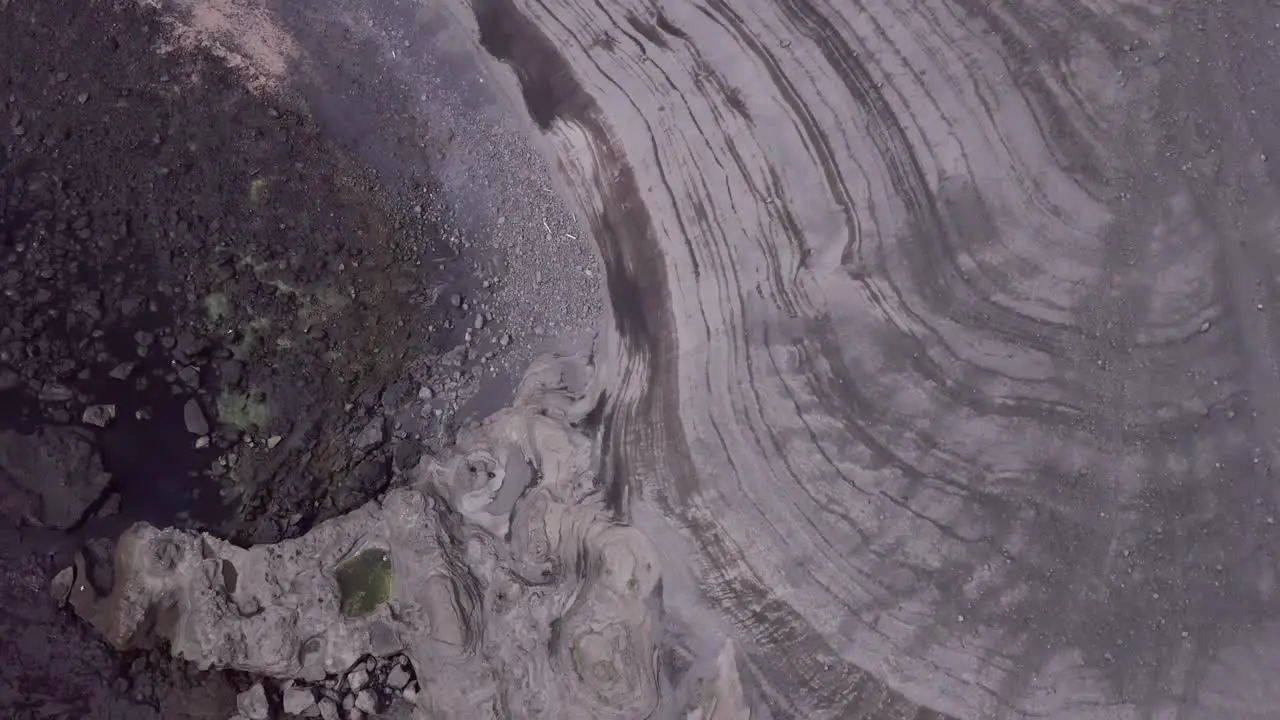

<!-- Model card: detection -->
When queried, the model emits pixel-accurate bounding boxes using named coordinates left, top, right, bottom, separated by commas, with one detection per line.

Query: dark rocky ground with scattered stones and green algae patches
left=0, top=0, right=460, bottom=717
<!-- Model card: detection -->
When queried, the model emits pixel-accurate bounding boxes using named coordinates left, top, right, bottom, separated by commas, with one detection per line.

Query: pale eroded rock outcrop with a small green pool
left=70, top=361, right=741, bottom=719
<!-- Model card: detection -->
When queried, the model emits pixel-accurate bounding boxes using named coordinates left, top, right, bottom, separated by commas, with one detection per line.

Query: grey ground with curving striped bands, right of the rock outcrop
left=475, top=0, right=1280, bottom=720
